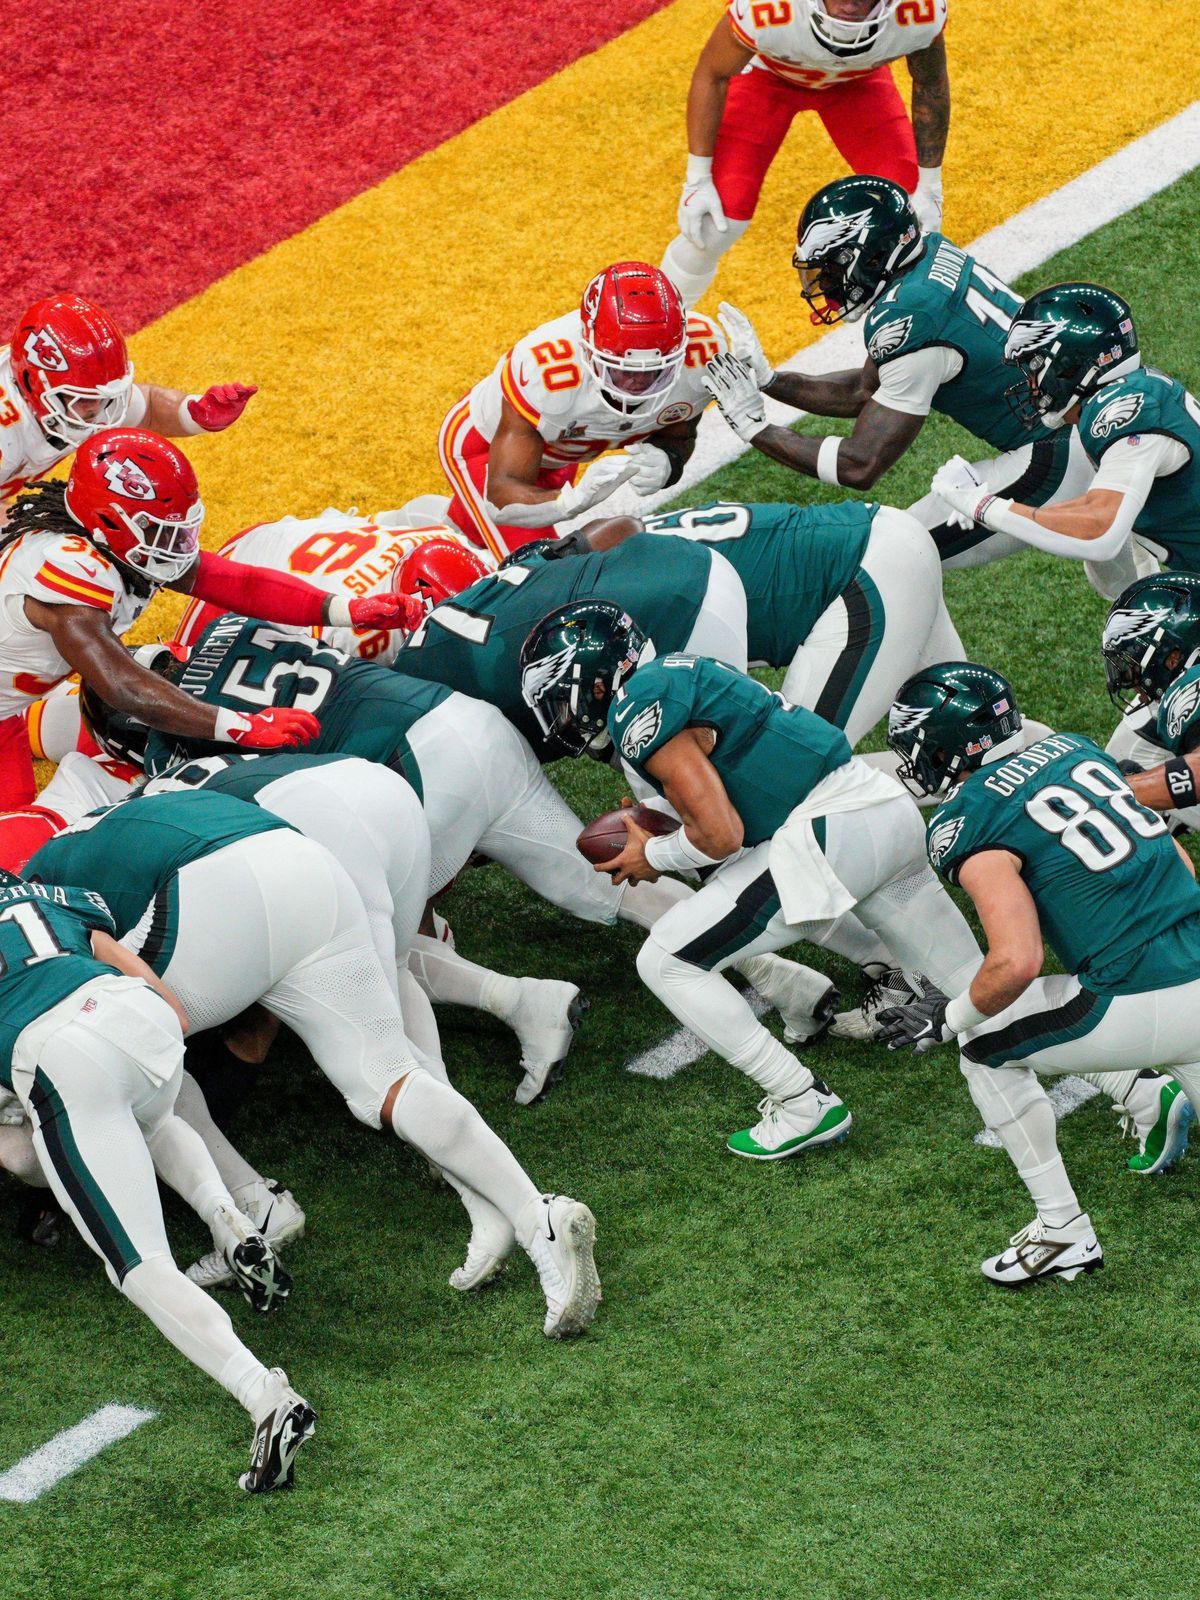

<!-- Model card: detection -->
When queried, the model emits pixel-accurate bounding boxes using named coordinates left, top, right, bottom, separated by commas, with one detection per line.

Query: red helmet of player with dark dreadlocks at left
left=66, top=427, right=205, bottom=584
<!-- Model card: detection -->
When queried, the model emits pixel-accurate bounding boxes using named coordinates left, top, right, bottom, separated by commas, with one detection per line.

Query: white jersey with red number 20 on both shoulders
left=470, top=310, right=726, bottom=472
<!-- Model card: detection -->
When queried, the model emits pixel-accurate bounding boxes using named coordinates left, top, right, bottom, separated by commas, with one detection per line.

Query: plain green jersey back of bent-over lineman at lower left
left=26, top=789, right=288, bottom=973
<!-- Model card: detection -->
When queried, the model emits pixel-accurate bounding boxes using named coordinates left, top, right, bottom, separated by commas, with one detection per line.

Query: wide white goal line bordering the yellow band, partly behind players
left=579, top=101, right=1200, bottom=528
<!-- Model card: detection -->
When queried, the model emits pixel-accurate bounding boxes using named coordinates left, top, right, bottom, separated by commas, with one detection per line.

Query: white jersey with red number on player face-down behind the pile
left=174, top=507, right=491, bottom=666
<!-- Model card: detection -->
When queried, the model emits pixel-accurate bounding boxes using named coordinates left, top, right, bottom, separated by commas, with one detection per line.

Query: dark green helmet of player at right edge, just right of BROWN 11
left=1005, top=283, right=1142, bottom=427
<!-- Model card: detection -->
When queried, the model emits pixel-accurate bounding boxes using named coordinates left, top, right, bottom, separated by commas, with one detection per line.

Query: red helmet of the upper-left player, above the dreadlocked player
left=13, top=294, right=133, bottom=450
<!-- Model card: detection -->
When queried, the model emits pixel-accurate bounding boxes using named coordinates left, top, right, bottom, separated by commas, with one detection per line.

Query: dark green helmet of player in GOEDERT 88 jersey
left=888, top=661, right=1021, bottom=797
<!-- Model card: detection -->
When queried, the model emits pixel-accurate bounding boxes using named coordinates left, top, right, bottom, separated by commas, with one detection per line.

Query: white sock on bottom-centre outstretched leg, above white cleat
left=392, top=1070, right=538, bottom=1243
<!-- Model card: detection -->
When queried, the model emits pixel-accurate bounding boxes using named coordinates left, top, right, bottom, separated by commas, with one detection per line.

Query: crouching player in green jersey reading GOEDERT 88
left=880, top=662, right=1200, bottom=1288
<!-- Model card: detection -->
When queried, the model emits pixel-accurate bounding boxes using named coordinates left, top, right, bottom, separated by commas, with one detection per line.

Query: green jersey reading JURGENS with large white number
left=146, top=614, right=451, bottom=794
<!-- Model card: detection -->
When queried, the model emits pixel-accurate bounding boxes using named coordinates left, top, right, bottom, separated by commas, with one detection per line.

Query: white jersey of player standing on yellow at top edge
left=728, top=0, right=947, bottom=90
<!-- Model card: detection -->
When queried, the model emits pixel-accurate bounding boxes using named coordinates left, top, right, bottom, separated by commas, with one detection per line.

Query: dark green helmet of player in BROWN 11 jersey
left=792, top=174, right=925, bottom=325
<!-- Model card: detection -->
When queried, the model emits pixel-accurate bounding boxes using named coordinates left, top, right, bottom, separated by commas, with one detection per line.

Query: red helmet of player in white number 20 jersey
left=579, top=261, right=688, bottom=413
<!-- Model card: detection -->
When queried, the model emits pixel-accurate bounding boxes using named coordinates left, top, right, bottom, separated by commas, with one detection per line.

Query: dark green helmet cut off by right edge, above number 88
left=1101, top=573, right=1200, bottom=709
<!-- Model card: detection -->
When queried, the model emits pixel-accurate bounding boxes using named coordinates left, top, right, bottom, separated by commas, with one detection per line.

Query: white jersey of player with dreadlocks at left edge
left=0, top=533, right=154, bottom=717
